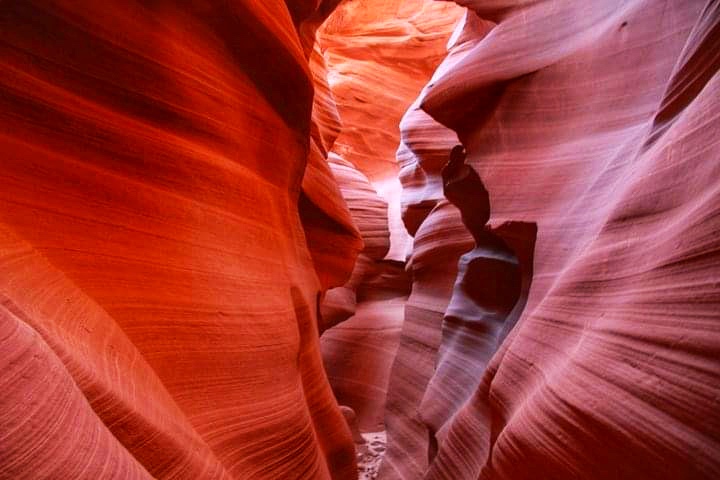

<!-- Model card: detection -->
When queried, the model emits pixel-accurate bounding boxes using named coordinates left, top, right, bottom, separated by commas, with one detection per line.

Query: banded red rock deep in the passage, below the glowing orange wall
left=320, top=158, right=409, bottom=432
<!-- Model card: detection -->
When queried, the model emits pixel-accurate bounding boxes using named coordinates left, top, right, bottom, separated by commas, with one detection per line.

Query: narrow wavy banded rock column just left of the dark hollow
left=381, top=39, right=473, bottom=478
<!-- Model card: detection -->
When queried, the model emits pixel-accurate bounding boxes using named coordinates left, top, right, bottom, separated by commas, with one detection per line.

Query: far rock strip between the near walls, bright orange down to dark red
left=317, top=0, right=462, bottom=432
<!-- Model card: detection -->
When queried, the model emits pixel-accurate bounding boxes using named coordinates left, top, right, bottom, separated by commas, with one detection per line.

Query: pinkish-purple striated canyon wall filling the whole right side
left=380, top=0, right=720, bottom=480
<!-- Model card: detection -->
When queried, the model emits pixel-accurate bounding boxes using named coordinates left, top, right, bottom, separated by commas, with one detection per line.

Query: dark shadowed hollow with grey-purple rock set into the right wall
left=419, top=145, right=537, bottom=462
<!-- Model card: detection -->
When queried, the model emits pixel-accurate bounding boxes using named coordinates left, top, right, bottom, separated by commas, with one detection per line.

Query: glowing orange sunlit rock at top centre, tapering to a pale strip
left=317, top=0, right=463, bottom=261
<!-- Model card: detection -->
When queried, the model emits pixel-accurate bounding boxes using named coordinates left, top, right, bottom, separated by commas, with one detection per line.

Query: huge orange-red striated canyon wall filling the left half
left=0, top=0, right=362, bottom=480
